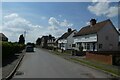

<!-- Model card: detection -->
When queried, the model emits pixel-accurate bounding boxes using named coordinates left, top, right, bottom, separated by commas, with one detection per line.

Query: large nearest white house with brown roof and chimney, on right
left=73, top=19, right=119, bottom=51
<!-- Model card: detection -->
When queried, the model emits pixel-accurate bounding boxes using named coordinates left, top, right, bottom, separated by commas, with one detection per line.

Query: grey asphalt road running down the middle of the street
left=14, top=48, right=111, bottom=78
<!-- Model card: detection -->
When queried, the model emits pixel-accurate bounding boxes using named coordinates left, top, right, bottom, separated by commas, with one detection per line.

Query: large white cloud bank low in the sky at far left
left=2, top=13, right=43, bottom=42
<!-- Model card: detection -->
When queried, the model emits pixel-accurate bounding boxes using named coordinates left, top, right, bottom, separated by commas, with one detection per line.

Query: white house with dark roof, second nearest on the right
left=58, top=28, right=76, bottom=50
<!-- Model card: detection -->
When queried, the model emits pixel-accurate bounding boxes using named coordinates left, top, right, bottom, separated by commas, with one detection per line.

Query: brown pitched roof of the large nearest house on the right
left=74, top=19, right=116, bottom=37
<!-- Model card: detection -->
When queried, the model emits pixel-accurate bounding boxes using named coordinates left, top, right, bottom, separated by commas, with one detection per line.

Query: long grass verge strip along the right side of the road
left=52, top=51, right=120, bottom=77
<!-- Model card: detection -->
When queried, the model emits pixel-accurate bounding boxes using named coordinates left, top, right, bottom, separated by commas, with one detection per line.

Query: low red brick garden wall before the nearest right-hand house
left=86, top=52, right=112, bottom=64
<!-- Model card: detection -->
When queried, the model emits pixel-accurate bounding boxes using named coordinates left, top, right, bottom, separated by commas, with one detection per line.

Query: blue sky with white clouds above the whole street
left=0, top=0, right=118, bottom=43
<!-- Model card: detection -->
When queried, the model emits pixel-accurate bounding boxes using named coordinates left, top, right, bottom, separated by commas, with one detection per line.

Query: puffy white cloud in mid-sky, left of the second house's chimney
left=48, top=17, right=73, bottom=37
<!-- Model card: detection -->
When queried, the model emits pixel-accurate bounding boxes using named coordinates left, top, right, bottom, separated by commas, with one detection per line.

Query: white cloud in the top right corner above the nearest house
left=88, top=2, right=118, bottom=17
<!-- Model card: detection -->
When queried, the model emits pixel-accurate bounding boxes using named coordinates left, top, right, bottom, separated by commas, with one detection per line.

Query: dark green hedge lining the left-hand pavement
left=2, top=42, right=25, bottom=58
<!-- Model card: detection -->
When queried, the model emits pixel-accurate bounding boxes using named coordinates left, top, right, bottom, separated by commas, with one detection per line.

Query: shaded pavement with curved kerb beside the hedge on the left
left=1, top=50, right=25, bottom=79
